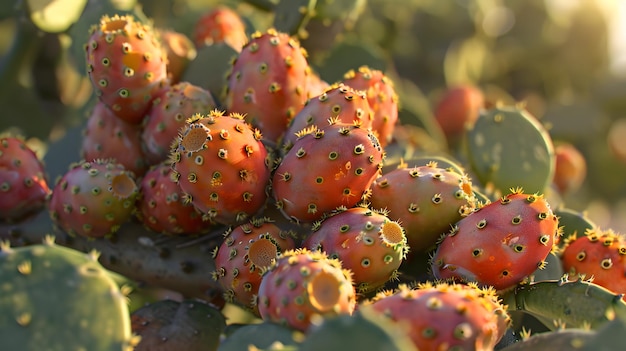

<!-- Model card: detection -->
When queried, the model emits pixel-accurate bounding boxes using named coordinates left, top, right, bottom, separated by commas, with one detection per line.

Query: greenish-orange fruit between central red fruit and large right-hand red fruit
left=369, top=161, right=476, bottom=252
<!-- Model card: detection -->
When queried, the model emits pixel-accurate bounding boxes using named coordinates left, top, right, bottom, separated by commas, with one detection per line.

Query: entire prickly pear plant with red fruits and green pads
left=0, top=2, right=626, bottom=351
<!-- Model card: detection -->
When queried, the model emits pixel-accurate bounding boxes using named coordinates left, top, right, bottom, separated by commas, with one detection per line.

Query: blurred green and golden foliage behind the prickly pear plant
left=0, top=0, right=626, bottom=232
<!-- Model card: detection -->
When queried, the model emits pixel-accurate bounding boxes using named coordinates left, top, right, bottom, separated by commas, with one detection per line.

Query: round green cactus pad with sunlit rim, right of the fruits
left=465, top=106, right=556, bottom=194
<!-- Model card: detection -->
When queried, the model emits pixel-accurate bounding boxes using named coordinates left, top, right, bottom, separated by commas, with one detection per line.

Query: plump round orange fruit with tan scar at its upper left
left=170, top=110, right=270, bottom=225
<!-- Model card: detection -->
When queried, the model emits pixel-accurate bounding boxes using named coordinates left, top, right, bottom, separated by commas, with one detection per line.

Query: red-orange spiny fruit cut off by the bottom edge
left=365, top=282, right=510, bottom=350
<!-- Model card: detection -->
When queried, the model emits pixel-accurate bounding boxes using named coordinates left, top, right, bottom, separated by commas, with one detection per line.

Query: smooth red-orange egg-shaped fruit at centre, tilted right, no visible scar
left=272, top=120, right=384, bottom=222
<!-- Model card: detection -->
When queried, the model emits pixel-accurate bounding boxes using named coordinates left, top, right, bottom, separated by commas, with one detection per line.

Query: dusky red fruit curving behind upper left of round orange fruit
left=141, top=82, right=217, bottom=164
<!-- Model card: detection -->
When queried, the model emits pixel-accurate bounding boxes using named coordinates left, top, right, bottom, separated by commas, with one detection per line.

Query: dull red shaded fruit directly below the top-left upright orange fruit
left=80, top=101, right=149, bottom=176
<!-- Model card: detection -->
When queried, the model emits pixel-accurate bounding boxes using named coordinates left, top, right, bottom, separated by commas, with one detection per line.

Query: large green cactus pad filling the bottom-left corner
left=0, top=238, right=133, bottom=351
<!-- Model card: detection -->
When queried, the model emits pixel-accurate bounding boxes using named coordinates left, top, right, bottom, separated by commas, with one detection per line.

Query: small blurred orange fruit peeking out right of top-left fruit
left=158, top=29, right=198, bottom=84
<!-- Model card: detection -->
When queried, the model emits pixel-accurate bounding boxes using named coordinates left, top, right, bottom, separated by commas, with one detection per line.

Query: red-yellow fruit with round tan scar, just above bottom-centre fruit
left=301, top=206, right=409, bottom=293
